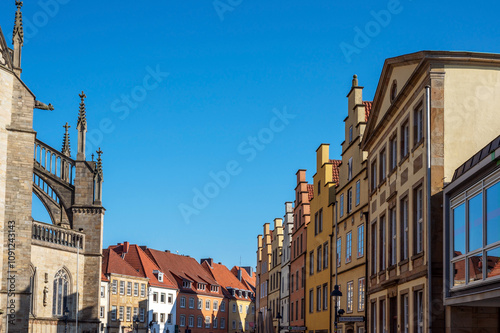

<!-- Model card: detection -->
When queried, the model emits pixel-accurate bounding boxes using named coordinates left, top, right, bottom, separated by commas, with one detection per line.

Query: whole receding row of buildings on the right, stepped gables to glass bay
left=256, top=51, right=500, bottom=333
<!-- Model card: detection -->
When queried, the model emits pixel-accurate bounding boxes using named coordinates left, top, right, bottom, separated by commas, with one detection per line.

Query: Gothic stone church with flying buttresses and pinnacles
left=0, top=1, right=104, bottom=332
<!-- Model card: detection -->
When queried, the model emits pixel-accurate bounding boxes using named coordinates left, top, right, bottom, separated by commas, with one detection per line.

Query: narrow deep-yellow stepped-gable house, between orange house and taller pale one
left=305, top=144, right=340, bottom=333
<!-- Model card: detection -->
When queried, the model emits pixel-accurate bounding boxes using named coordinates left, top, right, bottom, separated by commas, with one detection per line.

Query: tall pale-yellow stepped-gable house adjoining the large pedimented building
left=332, top=76, right=371, bottom=333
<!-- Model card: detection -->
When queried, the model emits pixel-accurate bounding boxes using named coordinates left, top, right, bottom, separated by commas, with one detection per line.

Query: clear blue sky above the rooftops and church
left=0, top=0, right=500, bottom=266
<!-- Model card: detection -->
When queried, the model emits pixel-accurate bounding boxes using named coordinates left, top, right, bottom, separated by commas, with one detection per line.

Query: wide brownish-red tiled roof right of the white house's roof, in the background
left=145, top=249, right=219, bottom=289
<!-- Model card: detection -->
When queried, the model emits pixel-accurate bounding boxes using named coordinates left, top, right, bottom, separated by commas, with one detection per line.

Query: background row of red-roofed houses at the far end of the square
left=100, top=242, right=255, bottom=333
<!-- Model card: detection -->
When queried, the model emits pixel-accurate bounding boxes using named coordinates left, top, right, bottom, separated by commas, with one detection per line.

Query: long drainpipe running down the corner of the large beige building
left=425, top=86, right=432, bottom=333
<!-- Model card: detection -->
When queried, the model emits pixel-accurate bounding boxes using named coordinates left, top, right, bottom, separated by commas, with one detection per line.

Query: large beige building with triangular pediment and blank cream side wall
left=362, top=51, right=500, bottom=332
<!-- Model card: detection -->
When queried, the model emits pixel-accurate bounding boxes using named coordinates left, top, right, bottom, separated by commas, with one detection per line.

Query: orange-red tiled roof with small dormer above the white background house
left=111, top=244, right=177, bottom=289
